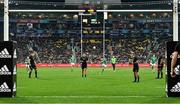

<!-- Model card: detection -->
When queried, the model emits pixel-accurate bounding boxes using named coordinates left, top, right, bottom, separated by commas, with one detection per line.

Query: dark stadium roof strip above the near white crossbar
left=9, top=0, right=172, bottom=9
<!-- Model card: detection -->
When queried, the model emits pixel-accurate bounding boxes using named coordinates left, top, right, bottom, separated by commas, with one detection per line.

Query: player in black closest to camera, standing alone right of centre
left=133, top=57, right=139, bottom=82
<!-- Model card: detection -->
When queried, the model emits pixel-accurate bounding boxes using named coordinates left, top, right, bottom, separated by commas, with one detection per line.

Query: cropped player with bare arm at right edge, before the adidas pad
left=171, top=43, right=180, bottom=78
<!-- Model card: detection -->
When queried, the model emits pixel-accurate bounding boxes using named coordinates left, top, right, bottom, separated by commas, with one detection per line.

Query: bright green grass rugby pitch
left=0, top=68, right=180, bottom=104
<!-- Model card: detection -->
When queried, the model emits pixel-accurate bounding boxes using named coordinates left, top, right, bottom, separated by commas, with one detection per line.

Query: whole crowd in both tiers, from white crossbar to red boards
left=10, top=13, right=173, bottom=63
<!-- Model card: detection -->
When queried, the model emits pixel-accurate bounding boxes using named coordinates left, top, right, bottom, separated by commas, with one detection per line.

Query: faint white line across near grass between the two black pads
left=17, top=96, right=164, bottom=98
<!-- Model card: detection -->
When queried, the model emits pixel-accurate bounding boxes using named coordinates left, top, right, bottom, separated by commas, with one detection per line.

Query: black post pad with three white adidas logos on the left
left=0, top=41, right=17, bottom=97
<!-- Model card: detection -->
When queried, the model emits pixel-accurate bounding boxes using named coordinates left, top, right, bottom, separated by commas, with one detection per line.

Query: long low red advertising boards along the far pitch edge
left=17, top=64, right=150, bottom=68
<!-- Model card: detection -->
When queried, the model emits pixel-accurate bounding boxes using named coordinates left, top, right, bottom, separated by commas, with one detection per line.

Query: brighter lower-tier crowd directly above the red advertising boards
left=16, top=37, right=168, bottom=64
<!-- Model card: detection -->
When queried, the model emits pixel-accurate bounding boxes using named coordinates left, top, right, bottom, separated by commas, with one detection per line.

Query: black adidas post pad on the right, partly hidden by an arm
left=166, top=42, right=180, bottom=97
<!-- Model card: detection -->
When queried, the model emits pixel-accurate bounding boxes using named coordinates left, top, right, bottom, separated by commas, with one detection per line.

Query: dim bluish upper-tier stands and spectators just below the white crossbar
left=10, top=13, right=172, bottom=38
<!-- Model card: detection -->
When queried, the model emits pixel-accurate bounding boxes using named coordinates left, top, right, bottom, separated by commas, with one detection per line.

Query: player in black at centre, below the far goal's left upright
left=80, top=54, right=88, bottom=77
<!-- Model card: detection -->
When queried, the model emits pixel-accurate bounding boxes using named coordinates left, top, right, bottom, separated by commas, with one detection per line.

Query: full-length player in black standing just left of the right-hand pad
left=157, top=56, right=164, bottom=79
